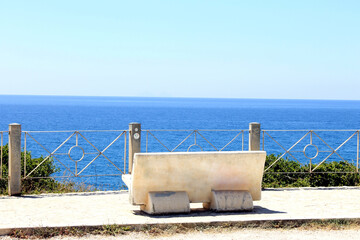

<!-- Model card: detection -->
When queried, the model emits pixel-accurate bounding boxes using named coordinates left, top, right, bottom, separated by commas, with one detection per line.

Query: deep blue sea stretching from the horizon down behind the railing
left=0, top=95, right=360, bottom=189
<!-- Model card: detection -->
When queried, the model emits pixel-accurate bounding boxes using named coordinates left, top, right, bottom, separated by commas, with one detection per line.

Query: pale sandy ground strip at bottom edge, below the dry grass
left=0, top=229, right=360, bottom=240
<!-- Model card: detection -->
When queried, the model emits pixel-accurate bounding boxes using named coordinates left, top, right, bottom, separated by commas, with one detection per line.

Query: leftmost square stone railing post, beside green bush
left=8, top=123, right=21, bottom=196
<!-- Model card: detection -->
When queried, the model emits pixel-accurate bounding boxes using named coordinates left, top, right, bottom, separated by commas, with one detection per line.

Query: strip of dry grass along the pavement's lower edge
left=10, top=219, right=360, bottom=239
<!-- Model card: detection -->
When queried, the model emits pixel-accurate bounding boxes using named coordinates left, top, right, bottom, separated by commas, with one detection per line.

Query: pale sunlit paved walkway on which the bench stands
left=0, top=187, right=360, bottom=233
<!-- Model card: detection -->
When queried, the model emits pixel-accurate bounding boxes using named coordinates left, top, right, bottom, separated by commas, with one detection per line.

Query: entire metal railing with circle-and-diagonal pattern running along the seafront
left=4, top=123, right=360, bottom=195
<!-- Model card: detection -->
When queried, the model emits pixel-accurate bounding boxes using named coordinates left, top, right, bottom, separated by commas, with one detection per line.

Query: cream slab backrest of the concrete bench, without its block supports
left=130, top=151, right=266, bottom=204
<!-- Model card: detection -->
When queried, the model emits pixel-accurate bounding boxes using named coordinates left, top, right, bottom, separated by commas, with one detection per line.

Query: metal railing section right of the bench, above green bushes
left=262, top=130, right=359, bottom=173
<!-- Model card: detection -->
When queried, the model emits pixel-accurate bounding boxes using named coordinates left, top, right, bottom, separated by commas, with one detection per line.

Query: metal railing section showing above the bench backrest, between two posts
left=142, top=129, right=248, bottom=152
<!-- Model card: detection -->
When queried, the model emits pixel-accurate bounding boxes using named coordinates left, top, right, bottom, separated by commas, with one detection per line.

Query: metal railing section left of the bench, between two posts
left=23, top=130, right=127, bottom=179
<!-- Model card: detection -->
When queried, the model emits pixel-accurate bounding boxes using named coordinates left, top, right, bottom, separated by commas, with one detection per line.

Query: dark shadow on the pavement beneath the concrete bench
left=133, top=206, right=286, bottom=218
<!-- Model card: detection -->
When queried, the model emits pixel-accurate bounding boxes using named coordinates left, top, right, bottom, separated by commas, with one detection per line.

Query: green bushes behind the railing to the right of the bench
left=263, top=154, right=360, bottom=188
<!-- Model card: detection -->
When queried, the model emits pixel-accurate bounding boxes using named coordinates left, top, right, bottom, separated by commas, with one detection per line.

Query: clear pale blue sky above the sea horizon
left=0, top=0, right=360, bottom=100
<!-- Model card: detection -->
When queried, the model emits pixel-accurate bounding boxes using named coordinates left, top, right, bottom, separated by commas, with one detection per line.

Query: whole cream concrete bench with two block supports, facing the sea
left=123, top=151, right=266, bottom=214
